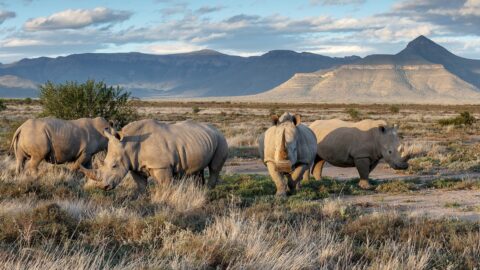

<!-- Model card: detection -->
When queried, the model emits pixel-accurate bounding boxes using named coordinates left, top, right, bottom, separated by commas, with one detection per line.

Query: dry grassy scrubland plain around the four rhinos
left=0, top=101, right=480, bottom=269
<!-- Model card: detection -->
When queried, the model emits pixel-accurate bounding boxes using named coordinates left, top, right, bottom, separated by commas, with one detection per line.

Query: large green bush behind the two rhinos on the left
left=40, top=80, right=137, bottom=126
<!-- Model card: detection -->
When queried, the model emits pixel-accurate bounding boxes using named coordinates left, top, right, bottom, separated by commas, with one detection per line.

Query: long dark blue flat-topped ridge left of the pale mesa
left=0, top=50, right=359, bottom=97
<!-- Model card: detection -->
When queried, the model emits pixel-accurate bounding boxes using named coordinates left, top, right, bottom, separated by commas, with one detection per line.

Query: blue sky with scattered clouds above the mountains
left=0, top=0, right=480, bottom=63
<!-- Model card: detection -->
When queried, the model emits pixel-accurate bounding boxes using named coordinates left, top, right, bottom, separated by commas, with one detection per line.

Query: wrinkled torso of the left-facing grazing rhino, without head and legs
left=122, top=120, right=226, bottom=174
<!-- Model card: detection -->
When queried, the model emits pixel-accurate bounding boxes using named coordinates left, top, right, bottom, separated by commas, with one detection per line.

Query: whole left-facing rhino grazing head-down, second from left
left=81, top=120, right=228, bottom=191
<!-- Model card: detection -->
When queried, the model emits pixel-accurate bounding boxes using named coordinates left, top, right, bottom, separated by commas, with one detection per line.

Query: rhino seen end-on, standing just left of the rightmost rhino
left=258, top=113, right=317, bottom=196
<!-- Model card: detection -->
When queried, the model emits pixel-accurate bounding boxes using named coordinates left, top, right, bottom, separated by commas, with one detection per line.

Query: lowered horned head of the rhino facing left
left=80, top=128, right=130, bottom=190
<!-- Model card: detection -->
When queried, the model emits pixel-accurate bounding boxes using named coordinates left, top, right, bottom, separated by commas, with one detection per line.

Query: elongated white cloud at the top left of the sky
left=24, top=7, right=132, bottom=31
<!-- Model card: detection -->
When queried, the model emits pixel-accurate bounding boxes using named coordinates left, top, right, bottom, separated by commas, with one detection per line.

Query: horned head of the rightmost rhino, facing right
left=377, top=126, right=408, bottom=170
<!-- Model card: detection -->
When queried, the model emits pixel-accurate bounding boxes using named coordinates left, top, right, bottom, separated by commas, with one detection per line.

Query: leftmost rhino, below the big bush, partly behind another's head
left=11, top=117, right=110, bottom=174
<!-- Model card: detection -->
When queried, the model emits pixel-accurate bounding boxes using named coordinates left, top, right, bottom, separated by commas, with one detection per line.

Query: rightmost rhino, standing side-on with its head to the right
left=310, top=119, right=409, bottom=189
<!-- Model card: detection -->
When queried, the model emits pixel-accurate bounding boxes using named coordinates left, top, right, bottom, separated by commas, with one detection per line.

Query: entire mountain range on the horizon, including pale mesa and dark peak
left=0, top=36, right=480, bottom=104
